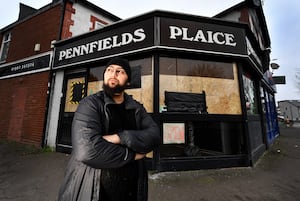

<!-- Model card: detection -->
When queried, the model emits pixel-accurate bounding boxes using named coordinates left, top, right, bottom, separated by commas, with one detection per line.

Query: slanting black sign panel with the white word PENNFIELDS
left=53, top=19, right=154, bottom=69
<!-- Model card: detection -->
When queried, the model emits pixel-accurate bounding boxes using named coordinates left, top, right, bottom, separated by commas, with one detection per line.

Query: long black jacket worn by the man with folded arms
left=58, top=91, right=160, bottom=201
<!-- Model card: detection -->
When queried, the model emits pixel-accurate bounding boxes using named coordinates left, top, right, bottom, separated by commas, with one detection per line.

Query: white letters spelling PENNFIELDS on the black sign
left=58, top=28, right=146, bottom=61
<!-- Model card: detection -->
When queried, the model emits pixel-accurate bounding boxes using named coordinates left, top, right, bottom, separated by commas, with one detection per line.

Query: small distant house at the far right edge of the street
left=278, top=100, right=300, bottom=121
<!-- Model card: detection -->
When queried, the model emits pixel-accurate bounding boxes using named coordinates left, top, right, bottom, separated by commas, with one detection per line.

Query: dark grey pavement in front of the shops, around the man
left=0, top=124, right=300, bottom=201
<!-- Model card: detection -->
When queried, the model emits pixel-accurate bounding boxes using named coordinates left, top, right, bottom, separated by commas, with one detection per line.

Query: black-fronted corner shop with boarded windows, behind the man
left=46, top=1, right=279, bottom=171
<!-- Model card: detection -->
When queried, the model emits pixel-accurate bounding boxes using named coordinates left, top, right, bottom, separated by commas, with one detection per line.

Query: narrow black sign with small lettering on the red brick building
left=0, top=53, right=51, bottom=79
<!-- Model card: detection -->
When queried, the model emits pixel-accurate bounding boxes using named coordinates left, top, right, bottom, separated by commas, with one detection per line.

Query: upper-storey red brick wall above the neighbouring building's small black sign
left=6, top=5, right=61, bottom=62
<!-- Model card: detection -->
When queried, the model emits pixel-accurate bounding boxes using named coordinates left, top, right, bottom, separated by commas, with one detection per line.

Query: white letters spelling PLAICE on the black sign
left=169, top=26, right=236, bottom=47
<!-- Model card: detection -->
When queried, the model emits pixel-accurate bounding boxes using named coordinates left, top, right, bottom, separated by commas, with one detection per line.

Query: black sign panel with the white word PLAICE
left=160, top=18, right=247, bottom=55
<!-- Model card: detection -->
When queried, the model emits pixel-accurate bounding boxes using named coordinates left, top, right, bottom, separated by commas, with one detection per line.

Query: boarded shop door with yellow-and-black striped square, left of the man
left=57, top=73, right=86, bottom=152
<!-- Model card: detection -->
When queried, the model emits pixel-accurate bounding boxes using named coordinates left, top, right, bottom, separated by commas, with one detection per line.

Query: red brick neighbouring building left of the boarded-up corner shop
left=0, top=0, right=120, bottom=146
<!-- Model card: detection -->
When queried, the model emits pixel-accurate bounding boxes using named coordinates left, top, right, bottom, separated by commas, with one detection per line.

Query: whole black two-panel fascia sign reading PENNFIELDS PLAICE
left=53, top=12, right=247, bottom=69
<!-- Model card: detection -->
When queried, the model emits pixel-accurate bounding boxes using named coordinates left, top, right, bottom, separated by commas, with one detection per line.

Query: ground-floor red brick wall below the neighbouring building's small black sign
left=0, top=72, right=49, bottom=146
